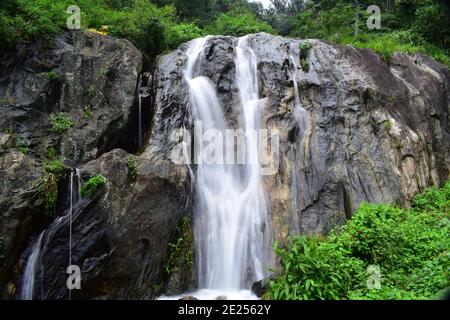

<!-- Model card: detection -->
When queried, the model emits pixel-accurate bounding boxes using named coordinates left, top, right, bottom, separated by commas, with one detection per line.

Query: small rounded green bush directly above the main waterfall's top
left=205, top=13, right=276, bottom=37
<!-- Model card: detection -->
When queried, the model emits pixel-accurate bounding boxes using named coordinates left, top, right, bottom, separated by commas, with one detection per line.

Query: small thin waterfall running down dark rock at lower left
left=20, top=169, right=81, bottom=300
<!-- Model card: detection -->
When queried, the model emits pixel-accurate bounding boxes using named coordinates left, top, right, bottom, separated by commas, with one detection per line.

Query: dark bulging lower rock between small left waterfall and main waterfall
left=29, top=149, right=186, bottom=300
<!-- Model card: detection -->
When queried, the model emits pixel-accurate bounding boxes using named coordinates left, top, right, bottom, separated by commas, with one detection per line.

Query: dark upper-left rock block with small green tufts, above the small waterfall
left=0, top=31, right=142, bottom=164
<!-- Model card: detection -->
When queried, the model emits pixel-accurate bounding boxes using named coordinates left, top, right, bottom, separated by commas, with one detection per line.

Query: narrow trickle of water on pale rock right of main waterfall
left=289, top=43, right=308, bottom=235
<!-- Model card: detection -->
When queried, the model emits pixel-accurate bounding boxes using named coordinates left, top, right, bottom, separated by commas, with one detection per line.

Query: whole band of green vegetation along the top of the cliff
left=0, top=0, right=450, bottom=65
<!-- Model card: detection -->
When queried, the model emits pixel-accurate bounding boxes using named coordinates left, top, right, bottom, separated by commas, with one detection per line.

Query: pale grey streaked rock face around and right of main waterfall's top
left=155, top=34, right=450, bottom=241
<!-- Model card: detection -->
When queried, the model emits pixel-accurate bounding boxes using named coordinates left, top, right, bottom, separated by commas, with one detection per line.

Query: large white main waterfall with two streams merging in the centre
left=184, top=37, right=271, bottom=296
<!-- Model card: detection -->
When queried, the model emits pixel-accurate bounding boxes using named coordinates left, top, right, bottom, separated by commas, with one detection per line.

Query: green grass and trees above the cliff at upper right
left=289, top=0, right=450, bottom=66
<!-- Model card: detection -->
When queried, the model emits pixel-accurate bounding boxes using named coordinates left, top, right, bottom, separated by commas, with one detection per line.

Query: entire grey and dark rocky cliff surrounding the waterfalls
left=0, top=32, right=450, bottom=299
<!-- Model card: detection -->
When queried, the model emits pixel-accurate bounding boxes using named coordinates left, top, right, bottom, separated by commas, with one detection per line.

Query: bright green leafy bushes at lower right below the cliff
left=269, top=182, right=450, bottom=300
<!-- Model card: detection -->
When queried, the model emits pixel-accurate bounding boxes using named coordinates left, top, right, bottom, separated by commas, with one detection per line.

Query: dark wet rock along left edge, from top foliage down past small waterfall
left=0, top=31, right=142, bottom=297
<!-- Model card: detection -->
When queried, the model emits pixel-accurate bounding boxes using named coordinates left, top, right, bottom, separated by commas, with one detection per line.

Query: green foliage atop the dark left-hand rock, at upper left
left=0, top=0, right=202, bottom=57
